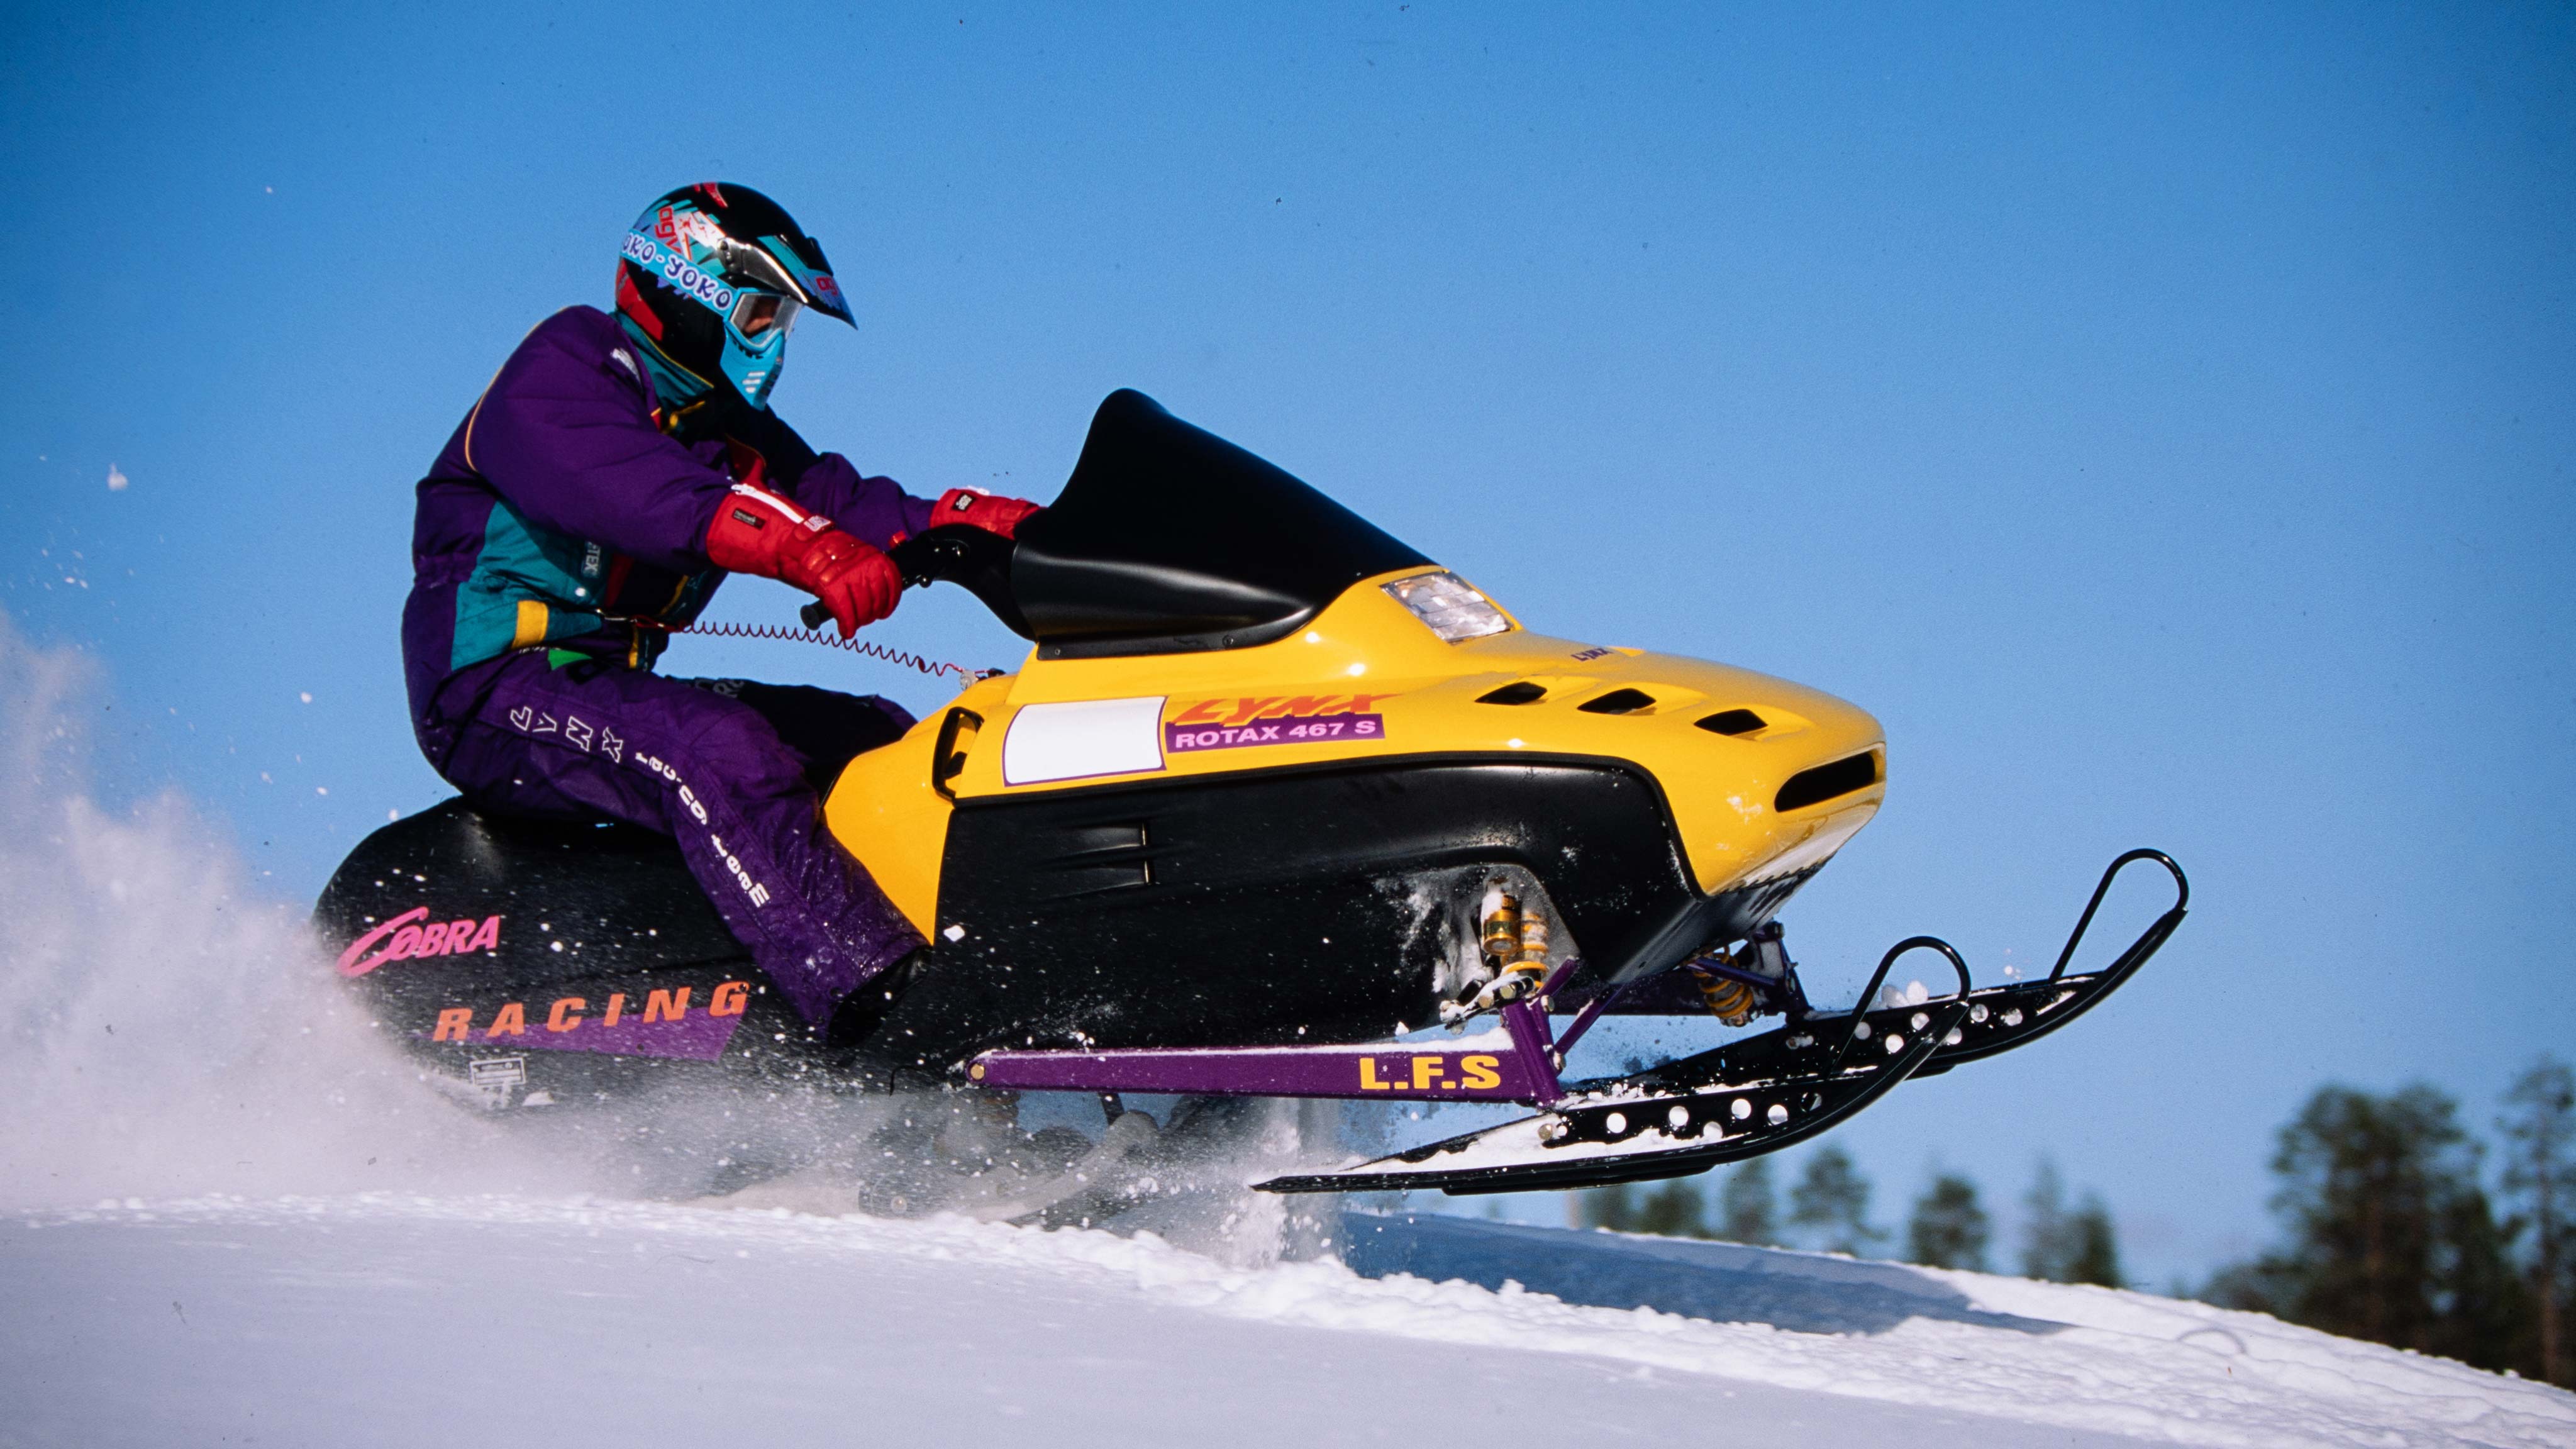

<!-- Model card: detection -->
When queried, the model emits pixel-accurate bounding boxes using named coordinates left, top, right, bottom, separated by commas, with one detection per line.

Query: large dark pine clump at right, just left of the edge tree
left=2205, top=1085, right=2527, bottom=1369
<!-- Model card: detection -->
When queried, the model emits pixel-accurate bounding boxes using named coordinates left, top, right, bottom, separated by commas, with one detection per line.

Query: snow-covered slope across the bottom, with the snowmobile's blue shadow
left=0, top=1194, right=2576, bottom=1449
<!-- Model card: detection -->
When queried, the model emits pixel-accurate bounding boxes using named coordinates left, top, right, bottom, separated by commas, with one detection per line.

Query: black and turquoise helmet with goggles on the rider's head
left=618, top=180, right=855, bottom=408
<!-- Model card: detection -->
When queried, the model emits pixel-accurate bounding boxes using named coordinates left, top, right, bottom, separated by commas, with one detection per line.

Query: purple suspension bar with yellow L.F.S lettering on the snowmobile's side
left=966, top=962, right=1597, bottom=1106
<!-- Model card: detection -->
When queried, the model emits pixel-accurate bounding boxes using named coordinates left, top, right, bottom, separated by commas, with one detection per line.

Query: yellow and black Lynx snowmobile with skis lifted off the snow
left=317, top=392, right=2190, bottom=1194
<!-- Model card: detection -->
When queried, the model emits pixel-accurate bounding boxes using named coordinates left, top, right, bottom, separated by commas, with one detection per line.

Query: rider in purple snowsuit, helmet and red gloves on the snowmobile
left=402, top=183, right=1038, bottom=1036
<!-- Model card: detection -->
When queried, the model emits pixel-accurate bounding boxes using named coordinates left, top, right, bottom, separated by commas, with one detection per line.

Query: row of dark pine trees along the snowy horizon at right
left=1574, top=1057, right=2576, bottom=1387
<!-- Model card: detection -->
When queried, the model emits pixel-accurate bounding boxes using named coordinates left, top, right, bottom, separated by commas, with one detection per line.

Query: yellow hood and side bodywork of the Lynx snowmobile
left=824, top=567, right=1885, bottom=936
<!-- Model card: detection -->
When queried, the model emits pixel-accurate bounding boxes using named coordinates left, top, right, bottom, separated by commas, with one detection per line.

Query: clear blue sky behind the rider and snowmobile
left=0, top=3, right=2576, bottom=1282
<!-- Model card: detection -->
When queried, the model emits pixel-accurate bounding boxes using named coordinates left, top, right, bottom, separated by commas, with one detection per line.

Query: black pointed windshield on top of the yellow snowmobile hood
left=1010, top=389, right=1432, bottom=657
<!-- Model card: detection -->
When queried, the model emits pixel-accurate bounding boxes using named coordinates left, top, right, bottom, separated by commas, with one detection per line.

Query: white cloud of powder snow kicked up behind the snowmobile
left=0, top=614, right=572, bottom=1207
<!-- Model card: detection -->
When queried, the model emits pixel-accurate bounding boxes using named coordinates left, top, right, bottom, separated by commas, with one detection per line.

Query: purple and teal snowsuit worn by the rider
left=402, top=307, right=930, bottom=1024
